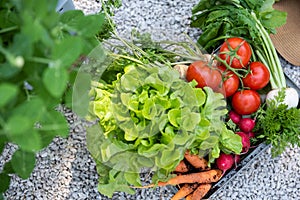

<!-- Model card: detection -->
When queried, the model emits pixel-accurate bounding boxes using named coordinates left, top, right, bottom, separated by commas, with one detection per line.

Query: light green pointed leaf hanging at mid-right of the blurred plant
left=43, top=67, right=69, bottom=98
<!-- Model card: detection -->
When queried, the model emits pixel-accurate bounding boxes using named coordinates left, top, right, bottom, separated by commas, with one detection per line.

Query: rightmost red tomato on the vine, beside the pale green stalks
left=242, top=62, right=270, bottom=90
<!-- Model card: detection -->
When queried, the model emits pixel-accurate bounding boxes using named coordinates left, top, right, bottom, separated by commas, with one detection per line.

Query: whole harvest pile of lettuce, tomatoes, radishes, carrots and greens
left=83, top=1, right=300, bottom=199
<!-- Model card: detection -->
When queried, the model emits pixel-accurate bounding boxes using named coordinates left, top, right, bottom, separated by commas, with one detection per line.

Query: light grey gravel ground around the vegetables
left=0, top=0, right=300, bottom=200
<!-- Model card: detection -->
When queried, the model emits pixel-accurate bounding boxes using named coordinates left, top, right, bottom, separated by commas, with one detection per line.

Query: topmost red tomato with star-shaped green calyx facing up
left=219, top=37, right=252, bottom=69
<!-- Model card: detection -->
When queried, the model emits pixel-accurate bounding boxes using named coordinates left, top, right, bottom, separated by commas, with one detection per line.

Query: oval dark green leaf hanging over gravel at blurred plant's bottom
left=11, top=149, right=35, bottom=179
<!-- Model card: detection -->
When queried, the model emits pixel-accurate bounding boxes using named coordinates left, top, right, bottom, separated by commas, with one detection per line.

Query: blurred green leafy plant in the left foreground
left=0, top=0, right=119, bottom=193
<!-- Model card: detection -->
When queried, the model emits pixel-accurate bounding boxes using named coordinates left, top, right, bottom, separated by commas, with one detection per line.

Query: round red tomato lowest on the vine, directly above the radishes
left=231, top=90, right=260, bottom=115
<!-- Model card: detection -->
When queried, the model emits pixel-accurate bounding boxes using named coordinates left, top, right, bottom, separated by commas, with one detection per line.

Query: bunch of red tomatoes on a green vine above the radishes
left=186, top=37, right=270, bottom=115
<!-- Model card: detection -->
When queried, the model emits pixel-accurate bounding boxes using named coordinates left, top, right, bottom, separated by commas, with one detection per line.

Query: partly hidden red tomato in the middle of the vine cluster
left=219, top=66, right=240, bottom=97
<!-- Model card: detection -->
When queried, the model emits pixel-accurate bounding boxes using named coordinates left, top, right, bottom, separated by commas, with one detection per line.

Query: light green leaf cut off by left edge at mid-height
left=0, top=83, right=19, bottom=108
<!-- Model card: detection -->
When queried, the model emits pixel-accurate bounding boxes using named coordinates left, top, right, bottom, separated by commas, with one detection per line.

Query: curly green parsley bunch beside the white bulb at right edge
left=255, top=90, right=300, bottom=157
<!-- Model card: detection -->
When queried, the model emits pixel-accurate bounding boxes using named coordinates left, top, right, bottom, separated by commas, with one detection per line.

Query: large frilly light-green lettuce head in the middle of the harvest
left=87, top=30, right=242, bottom=197
